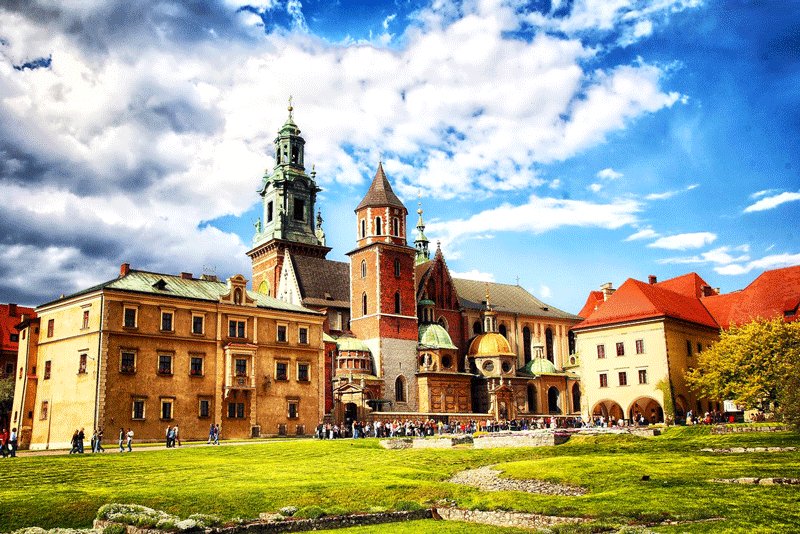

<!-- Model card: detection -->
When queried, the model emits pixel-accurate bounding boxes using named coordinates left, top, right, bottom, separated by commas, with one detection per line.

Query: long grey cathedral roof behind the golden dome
left=453, top=278, right=580, bottom=321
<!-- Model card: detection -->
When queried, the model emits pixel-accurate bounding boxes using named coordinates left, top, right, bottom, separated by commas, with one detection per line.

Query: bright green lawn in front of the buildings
left=0, top=427, right=800, bottom=533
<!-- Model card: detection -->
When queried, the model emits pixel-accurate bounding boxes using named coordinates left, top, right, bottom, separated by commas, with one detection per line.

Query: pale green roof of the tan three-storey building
left=40, top=269, right=316, bottom=313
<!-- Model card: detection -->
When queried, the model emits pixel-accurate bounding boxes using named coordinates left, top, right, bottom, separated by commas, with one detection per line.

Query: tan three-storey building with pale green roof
left=13, top=264, right=324, bottom=449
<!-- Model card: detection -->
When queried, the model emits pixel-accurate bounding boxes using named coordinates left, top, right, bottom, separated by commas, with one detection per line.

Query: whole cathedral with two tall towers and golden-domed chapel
left=248, top=105, right=581, bottom=422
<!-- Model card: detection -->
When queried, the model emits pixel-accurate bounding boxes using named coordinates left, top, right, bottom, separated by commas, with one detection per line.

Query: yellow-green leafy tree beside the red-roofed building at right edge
left=686, top=317, right=800, bottom=416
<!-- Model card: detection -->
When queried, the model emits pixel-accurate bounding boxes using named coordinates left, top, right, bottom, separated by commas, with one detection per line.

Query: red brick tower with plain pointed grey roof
left=347, top=163, right=419, bottom=411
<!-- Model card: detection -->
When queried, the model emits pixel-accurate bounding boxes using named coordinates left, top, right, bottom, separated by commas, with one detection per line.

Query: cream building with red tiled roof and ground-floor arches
left=573, top=266, right=800, bottom=428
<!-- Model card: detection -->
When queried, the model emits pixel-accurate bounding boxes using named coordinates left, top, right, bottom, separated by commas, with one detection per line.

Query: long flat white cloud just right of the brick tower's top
left=426, top=195, right=641, bottom=242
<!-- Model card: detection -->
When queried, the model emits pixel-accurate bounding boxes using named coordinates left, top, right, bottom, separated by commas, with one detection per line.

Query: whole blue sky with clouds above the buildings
left=0, top=0, right=800, bottom=313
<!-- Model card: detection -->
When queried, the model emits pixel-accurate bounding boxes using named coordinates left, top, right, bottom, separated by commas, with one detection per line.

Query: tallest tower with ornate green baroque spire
left=247, top=98, right=331, bottom=297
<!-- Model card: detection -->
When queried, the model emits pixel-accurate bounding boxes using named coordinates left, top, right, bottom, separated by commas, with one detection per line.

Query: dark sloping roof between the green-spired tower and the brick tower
left=292, top=254, right=350, bottom=308
